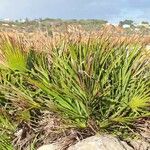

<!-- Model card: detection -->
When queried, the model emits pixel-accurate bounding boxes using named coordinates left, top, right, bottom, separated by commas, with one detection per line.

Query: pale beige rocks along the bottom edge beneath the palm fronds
left=38, top=135, right=150, bottom=150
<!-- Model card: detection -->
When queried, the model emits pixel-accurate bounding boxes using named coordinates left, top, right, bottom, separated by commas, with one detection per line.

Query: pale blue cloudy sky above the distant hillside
left=0, top=0, right=150, bottom=22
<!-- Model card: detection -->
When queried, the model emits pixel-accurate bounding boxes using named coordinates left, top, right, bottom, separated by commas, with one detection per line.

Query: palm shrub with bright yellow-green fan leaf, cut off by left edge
left=0, top=38, right=42, bottom=150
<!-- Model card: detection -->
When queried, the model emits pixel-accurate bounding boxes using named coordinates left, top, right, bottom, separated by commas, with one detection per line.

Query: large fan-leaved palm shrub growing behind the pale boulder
left=29, top=37, right=150, bottom=129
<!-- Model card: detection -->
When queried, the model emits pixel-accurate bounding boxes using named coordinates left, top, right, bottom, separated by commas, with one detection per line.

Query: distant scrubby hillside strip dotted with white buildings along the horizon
left=0, top=18, right=150, bottom=35
